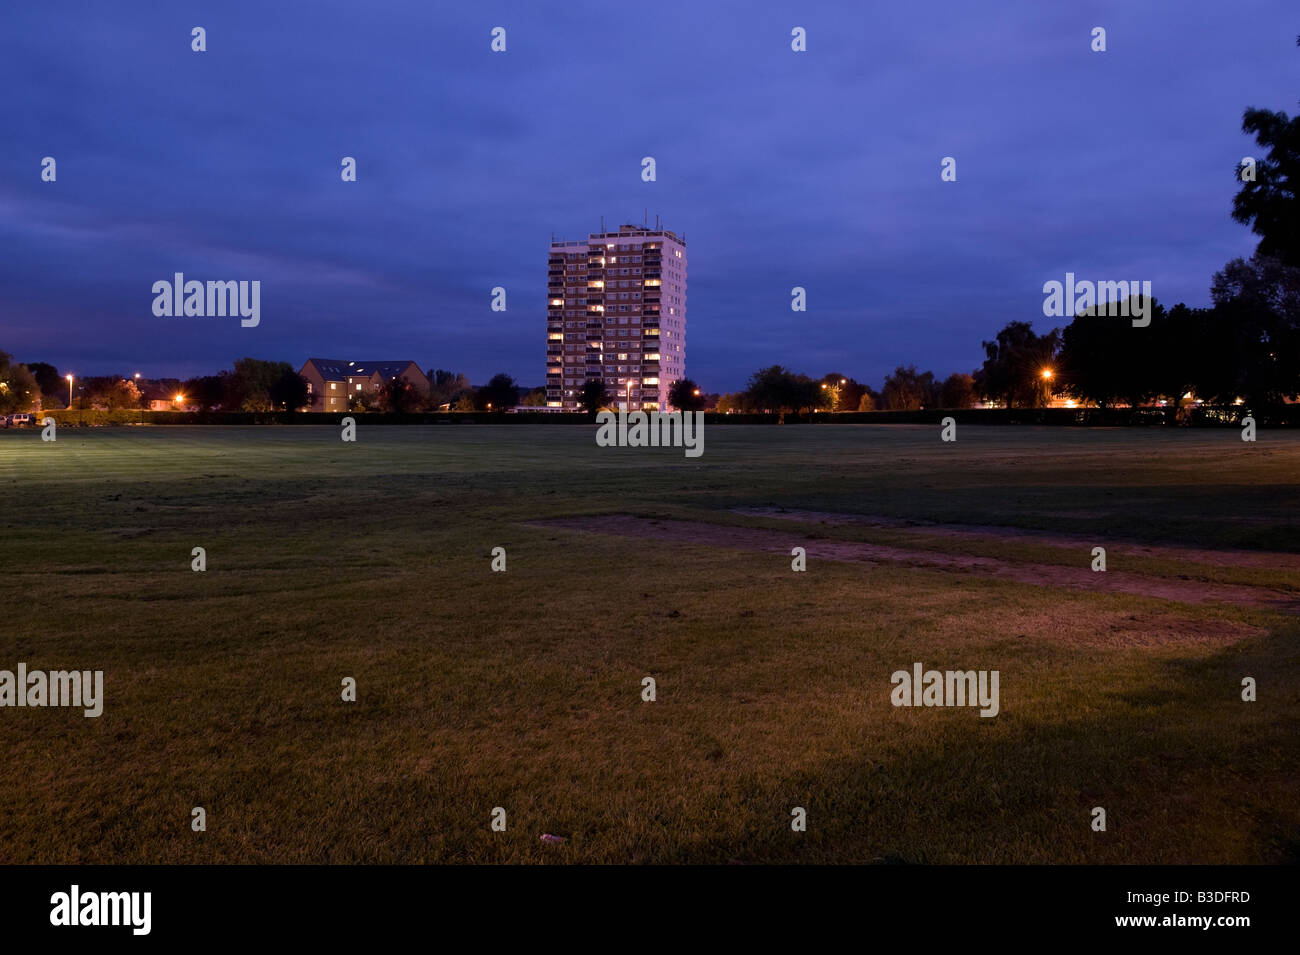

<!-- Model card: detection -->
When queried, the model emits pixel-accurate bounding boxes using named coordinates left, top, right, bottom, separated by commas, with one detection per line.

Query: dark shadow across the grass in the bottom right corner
left=681, top=626, right=1300, bottom=864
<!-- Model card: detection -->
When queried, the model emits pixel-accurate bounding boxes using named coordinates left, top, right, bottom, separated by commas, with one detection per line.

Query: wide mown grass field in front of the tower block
left=0, top=424, right=1300, bottom=863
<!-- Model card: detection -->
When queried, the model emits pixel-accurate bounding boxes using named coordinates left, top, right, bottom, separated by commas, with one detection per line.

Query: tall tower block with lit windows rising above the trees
left=546, top=225, right=686, bottom=411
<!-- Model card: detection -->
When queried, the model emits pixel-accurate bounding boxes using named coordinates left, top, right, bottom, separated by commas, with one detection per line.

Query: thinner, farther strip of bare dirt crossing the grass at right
left=733, top=507, right=1300, bottom=572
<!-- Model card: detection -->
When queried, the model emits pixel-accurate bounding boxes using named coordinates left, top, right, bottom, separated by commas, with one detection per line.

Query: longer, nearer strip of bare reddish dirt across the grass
left=532, top=515, right=1300, bottom=613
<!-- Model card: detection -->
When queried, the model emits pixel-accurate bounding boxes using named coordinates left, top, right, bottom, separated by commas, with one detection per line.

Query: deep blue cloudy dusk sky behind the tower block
left=0, top=0, right=1300, bottom=391
